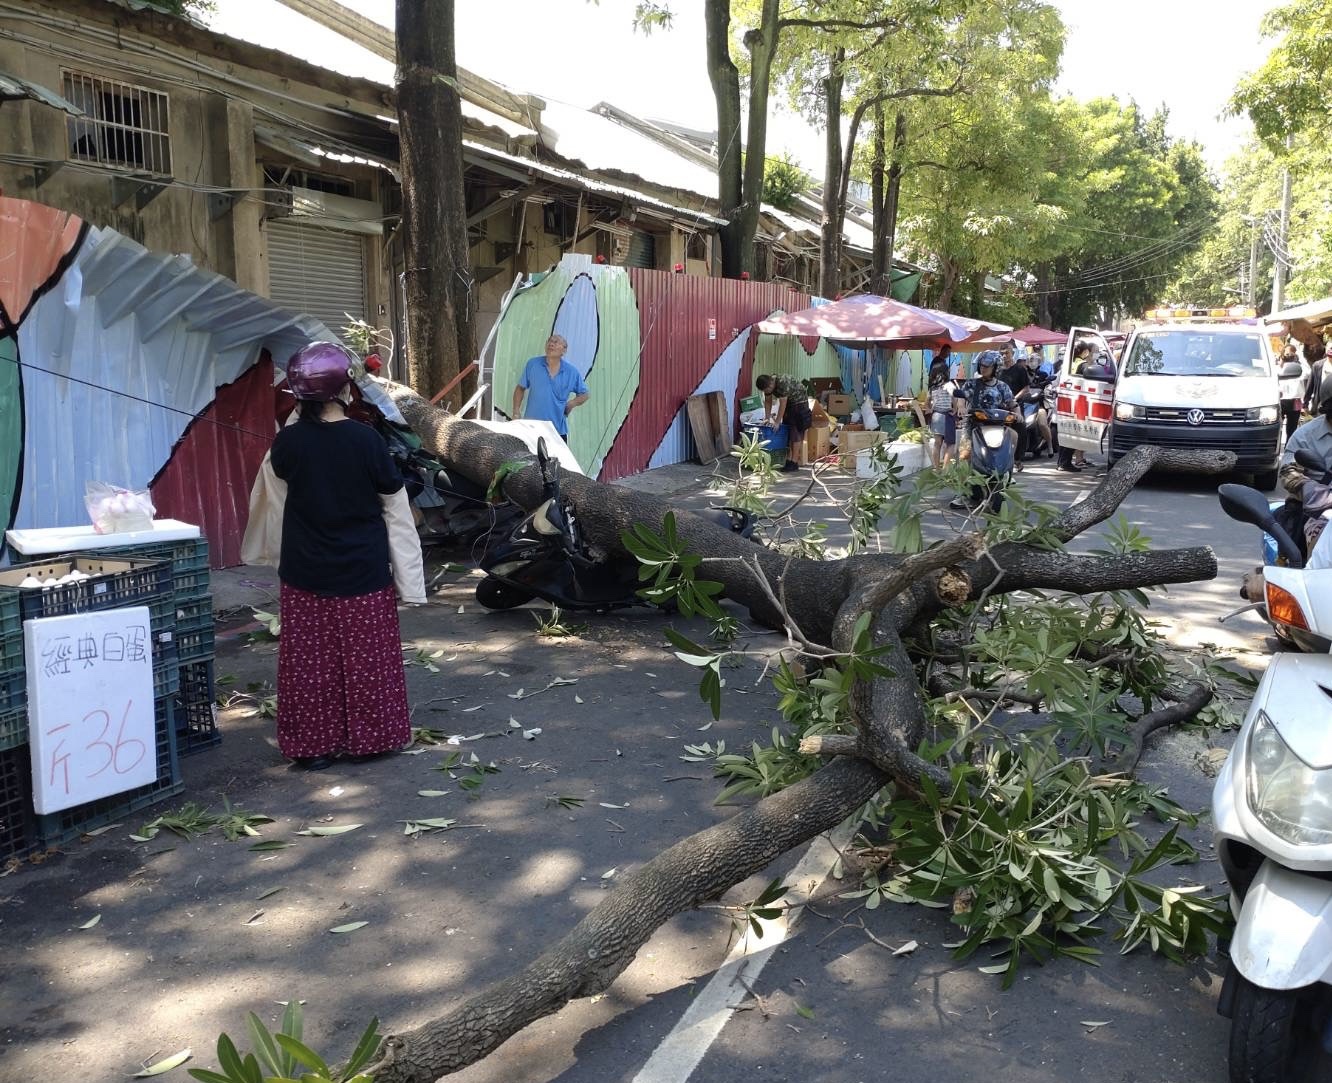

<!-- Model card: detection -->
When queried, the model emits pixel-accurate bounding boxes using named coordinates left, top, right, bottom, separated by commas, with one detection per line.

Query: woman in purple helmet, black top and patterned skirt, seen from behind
left=270, top=342, right=412, bottom=769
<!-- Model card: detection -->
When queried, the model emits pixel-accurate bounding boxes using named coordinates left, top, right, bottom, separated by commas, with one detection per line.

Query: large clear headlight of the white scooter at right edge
left=1245, top=711, right=1332, bottom=846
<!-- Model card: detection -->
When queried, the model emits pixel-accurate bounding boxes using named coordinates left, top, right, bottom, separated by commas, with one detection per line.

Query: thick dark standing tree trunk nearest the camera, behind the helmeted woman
left=396, top=0, right=477, bottom=402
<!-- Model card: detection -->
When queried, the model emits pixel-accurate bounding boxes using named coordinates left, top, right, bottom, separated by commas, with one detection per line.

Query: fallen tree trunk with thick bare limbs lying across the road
left=368, top=389, right=1231, bottom=1083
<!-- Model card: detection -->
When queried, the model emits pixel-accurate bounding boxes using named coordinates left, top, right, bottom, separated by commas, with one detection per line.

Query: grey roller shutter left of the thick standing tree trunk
left=265, top=218, right=369, bottom=334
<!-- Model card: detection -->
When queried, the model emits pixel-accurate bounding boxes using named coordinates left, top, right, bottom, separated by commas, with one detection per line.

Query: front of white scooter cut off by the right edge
left=1212, top=486, right=1332, bottom=1083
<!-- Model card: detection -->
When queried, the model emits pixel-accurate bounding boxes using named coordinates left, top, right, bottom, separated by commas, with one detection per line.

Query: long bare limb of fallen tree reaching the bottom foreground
left=365, top=759, right=887, bottom=1083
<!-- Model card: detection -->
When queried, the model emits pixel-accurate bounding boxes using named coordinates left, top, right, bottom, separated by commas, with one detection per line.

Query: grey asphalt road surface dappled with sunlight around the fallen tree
left=0, top=461, right=1289, bottom=1083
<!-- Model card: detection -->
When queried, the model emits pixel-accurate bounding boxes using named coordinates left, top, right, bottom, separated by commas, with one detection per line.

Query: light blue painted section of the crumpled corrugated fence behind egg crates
left=12, top=213, right=332, bottom=548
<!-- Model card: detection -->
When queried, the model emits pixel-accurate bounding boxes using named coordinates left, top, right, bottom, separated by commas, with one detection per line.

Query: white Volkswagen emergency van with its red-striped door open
left=1056, top=309, right=1281, bottom=492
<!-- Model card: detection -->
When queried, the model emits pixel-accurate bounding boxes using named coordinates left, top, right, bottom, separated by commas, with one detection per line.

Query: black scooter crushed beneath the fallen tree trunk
left=477, top=440, right=754, bottom=613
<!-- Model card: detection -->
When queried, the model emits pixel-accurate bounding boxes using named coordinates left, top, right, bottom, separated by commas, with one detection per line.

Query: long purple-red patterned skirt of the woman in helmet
left=277, top=583, right=412, bottom=759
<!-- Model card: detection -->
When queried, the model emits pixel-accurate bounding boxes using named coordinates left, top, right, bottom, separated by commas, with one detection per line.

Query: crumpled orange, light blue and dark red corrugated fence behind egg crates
left=0, top=197, right=330, bottom=566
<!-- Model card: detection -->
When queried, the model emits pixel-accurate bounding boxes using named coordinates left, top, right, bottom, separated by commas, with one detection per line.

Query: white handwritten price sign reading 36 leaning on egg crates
left=23, top=606, right=157, bottom=813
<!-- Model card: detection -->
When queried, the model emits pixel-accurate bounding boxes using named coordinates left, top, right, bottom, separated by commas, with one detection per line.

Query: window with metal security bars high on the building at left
left=64, top=72, right=170, bottom=176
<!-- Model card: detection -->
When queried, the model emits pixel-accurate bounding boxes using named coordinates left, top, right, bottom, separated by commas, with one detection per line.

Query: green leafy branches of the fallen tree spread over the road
left=626, top=450, right=1252, bottom=984
